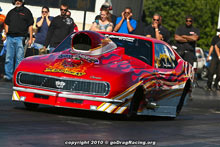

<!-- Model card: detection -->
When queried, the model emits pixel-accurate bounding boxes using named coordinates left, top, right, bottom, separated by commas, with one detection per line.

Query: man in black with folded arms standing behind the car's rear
left=174, top=15, right=200, bottom=65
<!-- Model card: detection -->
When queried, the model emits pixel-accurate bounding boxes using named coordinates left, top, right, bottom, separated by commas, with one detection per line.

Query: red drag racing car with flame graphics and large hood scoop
left=12, top=31, right=193, bottom=117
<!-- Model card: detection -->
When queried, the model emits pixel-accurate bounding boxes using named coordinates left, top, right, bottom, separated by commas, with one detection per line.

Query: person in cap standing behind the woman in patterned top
left=95, top=2, right=117, bottom=28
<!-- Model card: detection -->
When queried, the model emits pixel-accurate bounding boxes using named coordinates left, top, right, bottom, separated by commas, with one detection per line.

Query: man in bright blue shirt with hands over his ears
left=114, top=7, right=137, bottom=34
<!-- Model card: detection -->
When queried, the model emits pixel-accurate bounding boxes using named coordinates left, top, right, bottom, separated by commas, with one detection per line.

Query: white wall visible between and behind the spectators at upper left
left=0, top=0, right=105, bottom=30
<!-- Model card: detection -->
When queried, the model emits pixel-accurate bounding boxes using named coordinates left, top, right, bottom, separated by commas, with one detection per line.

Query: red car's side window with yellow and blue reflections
left=155, top=43, right=177, bottom=69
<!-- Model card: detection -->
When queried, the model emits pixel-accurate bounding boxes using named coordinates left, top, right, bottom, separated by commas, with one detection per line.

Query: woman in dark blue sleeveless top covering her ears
left=33, top=6, right=53, bottom=49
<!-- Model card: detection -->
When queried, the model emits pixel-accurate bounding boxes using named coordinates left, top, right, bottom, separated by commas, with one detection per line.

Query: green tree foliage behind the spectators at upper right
left=144, top=0, right=220, bottom=50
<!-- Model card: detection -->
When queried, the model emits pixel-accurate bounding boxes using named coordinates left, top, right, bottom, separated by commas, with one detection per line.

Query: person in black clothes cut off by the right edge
left=206, top=28, right=220, bottom=91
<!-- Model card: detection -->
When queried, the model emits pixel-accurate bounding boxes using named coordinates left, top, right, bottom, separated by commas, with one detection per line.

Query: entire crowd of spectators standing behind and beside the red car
left=0, top=0, right=220, bottom=90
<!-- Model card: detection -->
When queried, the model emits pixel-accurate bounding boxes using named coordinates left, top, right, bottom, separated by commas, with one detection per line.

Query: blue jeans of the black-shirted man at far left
left=5, top=36, right=24, bottom=80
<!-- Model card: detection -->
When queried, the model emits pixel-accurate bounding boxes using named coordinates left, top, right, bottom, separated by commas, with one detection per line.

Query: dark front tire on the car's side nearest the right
left=127, top=86, right=144, bottom=118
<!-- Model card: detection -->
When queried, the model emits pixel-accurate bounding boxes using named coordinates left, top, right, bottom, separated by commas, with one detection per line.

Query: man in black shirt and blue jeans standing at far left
left=3, top=0, right=34, bottom=82
